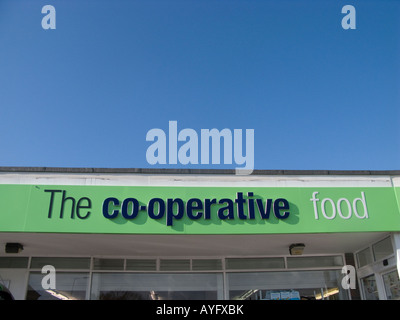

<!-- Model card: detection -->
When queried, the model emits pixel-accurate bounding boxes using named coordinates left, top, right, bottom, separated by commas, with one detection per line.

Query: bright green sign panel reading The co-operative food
left=0, top=185, right=400, bottom=234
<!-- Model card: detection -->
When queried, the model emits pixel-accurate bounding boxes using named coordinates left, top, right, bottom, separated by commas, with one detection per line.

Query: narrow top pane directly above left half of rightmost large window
left=226, top=258, right=285, bottom=270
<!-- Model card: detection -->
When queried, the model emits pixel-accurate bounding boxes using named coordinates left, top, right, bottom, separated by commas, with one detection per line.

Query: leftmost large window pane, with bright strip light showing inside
left=26, top=272, right=89, bottom=300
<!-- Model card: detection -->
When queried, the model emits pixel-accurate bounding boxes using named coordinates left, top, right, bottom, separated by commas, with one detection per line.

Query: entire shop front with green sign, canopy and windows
left=0, top=168, right=400, bottom=300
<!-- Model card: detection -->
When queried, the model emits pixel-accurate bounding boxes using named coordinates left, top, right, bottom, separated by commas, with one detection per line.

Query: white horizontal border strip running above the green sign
left=0, top=173, right=394, bottom=187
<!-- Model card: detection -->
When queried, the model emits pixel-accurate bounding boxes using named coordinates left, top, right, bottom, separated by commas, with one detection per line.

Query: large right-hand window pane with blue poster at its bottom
left=227, top=270, right=348, bottom=300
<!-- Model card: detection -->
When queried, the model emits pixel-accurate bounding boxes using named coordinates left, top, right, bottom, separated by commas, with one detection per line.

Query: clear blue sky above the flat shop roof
left=0, top=0, right=400, bottom=170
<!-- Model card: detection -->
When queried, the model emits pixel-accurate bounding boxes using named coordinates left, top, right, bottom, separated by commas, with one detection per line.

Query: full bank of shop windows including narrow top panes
left=26, top=255, right=349, bottom=300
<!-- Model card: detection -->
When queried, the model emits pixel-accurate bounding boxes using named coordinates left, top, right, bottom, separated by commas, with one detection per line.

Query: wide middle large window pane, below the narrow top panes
left=91, top=273, right=223, bottom=300
